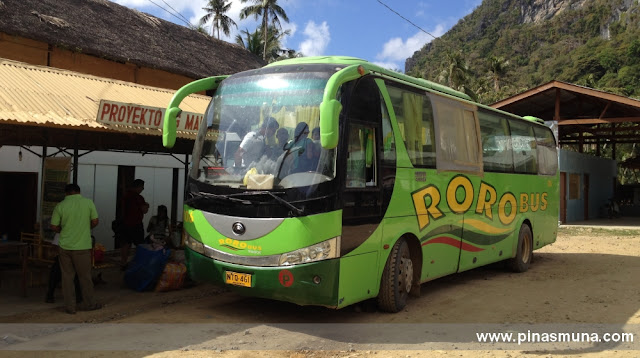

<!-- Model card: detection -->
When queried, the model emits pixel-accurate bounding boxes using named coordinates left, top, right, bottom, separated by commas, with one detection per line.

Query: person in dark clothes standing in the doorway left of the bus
left=119, top=179, right=149, bottom=268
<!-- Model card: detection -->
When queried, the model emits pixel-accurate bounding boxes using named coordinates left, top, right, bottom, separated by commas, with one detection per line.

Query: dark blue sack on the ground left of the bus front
left=124, top=245, right=171, bottom=291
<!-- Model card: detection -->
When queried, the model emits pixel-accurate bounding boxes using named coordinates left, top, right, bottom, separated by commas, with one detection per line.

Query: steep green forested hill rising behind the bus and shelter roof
left=405, top=0, right=640, bottom=104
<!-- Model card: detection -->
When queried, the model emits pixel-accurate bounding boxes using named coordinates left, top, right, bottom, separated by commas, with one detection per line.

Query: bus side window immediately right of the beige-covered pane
left=478, top=110, right=513, bottom=173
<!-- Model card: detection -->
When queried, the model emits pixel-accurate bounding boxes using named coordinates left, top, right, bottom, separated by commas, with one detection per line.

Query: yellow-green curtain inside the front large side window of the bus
left=402, top=92, right=423, bottom=164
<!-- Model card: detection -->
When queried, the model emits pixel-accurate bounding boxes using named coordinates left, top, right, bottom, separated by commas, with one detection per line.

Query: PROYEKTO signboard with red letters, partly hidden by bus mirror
left=97, top=99, right=204, bottom=132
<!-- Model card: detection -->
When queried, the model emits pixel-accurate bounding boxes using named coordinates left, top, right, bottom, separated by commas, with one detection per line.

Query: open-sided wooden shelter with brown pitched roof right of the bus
left=491, top=81, right=640, bottom=221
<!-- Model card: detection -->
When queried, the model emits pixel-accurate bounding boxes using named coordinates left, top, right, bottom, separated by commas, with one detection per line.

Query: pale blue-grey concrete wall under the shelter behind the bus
left=560, top=150, right=618, bottom=222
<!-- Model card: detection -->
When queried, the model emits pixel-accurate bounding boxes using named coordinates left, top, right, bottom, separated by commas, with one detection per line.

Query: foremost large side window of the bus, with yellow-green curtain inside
left=387, top=82, right=436, bottom=168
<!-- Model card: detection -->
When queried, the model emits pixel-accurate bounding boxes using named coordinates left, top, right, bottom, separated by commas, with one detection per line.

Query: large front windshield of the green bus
left=190, top=68, right=335, bottom=190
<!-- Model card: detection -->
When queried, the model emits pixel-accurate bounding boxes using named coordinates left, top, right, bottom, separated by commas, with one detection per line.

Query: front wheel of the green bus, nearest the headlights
left=378, top=239, right=413, bottom=312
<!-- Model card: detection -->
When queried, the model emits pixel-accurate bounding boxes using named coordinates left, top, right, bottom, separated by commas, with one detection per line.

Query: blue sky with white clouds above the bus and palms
left=115, top=0, right=482, bottom=71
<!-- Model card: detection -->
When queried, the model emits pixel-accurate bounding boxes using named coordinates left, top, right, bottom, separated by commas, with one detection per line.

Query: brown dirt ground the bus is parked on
left=0, top=226, right=640, bottom=358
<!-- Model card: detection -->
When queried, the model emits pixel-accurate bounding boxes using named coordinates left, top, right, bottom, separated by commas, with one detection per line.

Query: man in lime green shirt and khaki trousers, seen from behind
left=51, top=184, right=102, bottom=314
